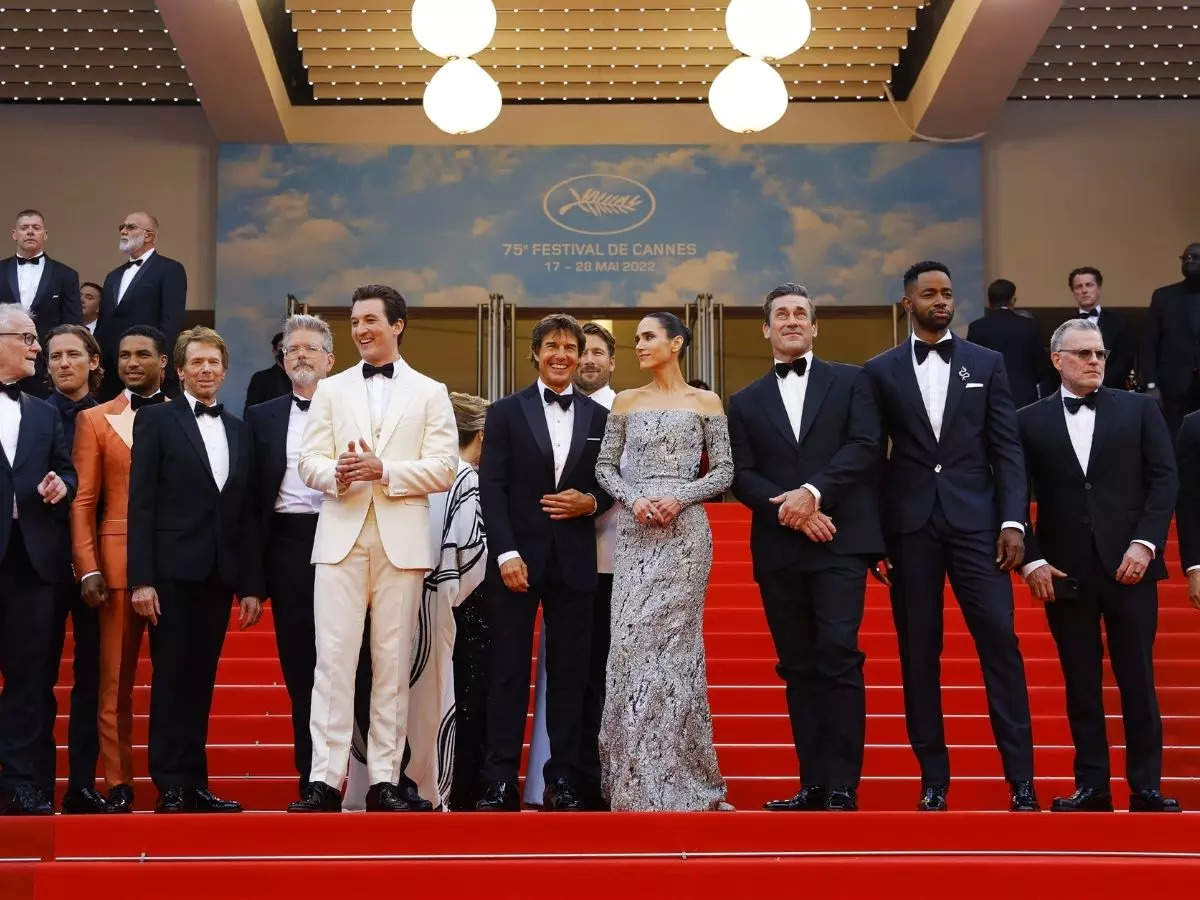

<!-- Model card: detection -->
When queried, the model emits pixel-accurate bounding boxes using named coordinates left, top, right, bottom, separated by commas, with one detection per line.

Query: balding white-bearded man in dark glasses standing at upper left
left=96, top=212, right=187, bottom=401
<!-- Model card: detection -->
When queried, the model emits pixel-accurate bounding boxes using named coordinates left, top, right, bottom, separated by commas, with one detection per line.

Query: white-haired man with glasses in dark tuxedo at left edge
left=0, top=305, right=77, bottom=816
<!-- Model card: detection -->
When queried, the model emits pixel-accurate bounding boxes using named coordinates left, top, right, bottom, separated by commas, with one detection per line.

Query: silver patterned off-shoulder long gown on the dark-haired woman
left=596, top=409, right=733, bottom=810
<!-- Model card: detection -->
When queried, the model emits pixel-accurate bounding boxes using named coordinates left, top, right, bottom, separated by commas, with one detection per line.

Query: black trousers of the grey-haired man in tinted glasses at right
left=1046, top=559, right=1163, bottom=791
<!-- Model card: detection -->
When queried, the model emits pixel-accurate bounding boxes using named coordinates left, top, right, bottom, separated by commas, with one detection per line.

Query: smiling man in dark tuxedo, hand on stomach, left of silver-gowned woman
left=476, top=313, right=612, bottom=811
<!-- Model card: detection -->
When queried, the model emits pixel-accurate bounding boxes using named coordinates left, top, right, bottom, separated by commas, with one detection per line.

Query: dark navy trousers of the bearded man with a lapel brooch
left=888, top=504, right=1033, bottom=784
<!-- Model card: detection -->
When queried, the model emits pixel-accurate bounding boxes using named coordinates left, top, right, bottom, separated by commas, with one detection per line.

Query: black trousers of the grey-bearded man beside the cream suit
left=266, top=512, right=317, bottom=792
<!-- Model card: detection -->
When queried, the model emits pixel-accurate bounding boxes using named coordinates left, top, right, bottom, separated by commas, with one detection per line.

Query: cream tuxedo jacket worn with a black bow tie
left=298, top=359, right=458, bottom=569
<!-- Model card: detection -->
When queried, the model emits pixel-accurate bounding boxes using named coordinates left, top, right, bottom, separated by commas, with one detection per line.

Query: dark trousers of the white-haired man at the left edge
left=0, top=525, right=60, bottom=791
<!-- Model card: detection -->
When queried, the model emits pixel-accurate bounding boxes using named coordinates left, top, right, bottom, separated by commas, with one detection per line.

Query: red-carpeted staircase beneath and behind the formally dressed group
left=0, top=504, right=1200, bottom=899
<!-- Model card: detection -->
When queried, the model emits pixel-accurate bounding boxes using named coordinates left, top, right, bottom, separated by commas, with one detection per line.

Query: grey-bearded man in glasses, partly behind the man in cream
left=245, top=316, right=336, bottom=797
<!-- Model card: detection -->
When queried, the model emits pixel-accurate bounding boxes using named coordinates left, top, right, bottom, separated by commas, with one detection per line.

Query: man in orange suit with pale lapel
left=71, top=325, right=167, bottom=812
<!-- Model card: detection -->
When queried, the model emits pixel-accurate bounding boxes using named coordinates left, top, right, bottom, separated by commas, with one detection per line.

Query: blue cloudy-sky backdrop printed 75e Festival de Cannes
left=216, top=144, right=983, bottom=408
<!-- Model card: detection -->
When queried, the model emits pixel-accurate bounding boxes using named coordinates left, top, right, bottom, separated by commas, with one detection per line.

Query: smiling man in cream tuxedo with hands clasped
left=288, top=284, right=458, bottom=812
